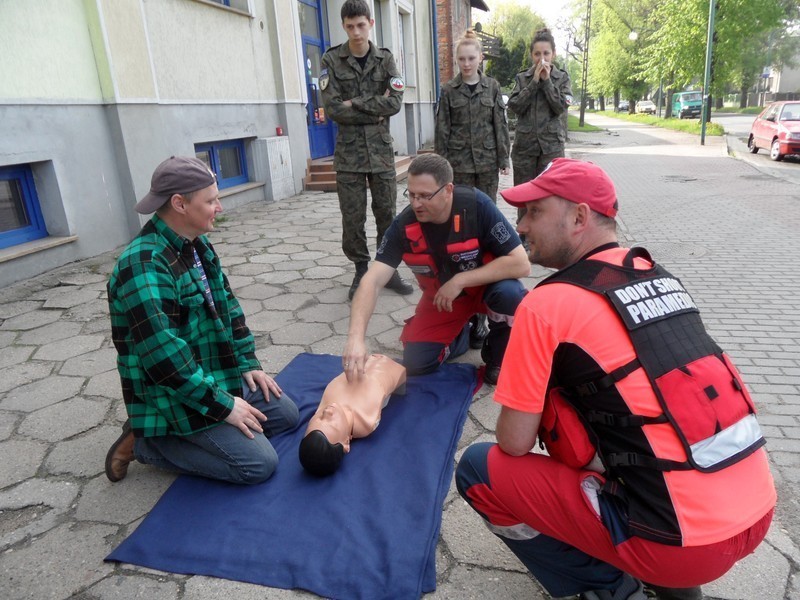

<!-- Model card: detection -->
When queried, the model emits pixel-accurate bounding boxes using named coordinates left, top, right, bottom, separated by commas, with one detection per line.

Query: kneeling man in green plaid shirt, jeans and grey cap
left=105, top=156, right=299, bottom=484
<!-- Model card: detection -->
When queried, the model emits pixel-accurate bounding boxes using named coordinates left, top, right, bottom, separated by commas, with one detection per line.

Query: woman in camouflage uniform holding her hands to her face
left=508, top=29, right=572, bottom=190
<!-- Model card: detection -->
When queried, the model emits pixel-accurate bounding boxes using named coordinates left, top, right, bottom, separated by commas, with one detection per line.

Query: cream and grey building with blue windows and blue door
left=0, top=0, right=438, bottom=285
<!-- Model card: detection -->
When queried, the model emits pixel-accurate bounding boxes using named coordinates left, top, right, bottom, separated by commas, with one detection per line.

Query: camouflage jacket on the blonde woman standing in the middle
left=435, top=74, right=511, bottom=173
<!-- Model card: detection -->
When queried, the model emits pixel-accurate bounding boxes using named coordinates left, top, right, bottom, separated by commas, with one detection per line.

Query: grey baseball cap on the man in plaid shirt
left=136, top=156, right=217, bottom=215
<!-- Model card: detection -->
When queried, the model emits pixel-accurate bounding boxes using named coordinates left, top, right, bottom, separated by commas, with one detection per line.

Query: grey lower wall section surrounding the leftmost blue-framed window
left=0, top=104, right=133, bottom=286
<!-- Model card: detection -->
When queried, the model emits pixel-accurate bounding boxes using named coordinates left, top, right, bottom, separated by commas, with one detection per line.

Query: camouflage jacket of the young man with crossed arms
left=319, top=42, right=405, bottom=173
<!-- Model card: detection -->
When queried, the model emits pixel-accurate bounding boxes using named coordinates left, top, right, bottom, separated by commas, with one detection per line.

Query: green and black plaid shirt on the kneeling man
left=108, top=215, right=261, bottom=437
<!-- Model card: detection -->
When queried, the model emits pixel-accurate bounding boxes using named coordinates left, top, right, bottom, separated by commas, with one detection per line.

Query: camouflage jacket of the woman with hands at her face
left=508, top=67, right=572, bottom=158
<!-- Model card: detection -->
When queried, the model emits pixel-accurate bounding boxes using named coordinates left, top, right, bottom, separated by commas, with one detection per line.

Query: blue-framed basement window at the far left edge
left=0, top=165, right=47, bottom=248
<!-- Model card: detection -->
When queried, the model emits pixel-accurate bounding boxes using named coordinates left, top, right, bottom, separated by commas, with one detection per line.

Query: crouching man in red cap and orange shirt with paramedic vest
left=456, top=158, right=776, bottom=600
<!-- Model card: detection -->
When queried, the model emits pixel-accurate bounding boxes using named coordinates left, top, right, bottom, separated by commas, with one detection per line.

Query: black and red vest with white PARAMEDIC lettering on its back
left=539, top=248, right=765, bottom=473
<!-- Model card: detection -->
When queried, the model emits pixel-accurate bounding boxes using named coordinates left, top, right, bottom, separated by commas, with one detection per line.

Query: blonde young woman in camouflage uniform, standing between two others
left=435, top=31, right=510, bottom=202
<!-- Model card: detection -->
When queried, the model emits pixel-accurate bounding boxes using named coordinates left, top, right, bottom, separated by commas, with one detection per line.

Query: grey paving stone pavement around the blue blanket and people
left=0, top=116, right=800, bottom=600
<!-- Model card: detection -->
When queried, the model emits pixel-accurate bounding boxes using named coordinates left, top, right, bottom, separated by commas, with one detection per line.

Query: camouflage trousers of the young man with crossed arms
left=336, top=170, right=397, bottom=263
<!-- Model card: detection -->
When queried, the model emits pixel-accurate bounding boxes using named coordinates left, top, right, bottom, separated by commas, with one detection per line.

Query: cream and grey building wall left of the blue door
left=0, top=0, right=308, bottom=285
